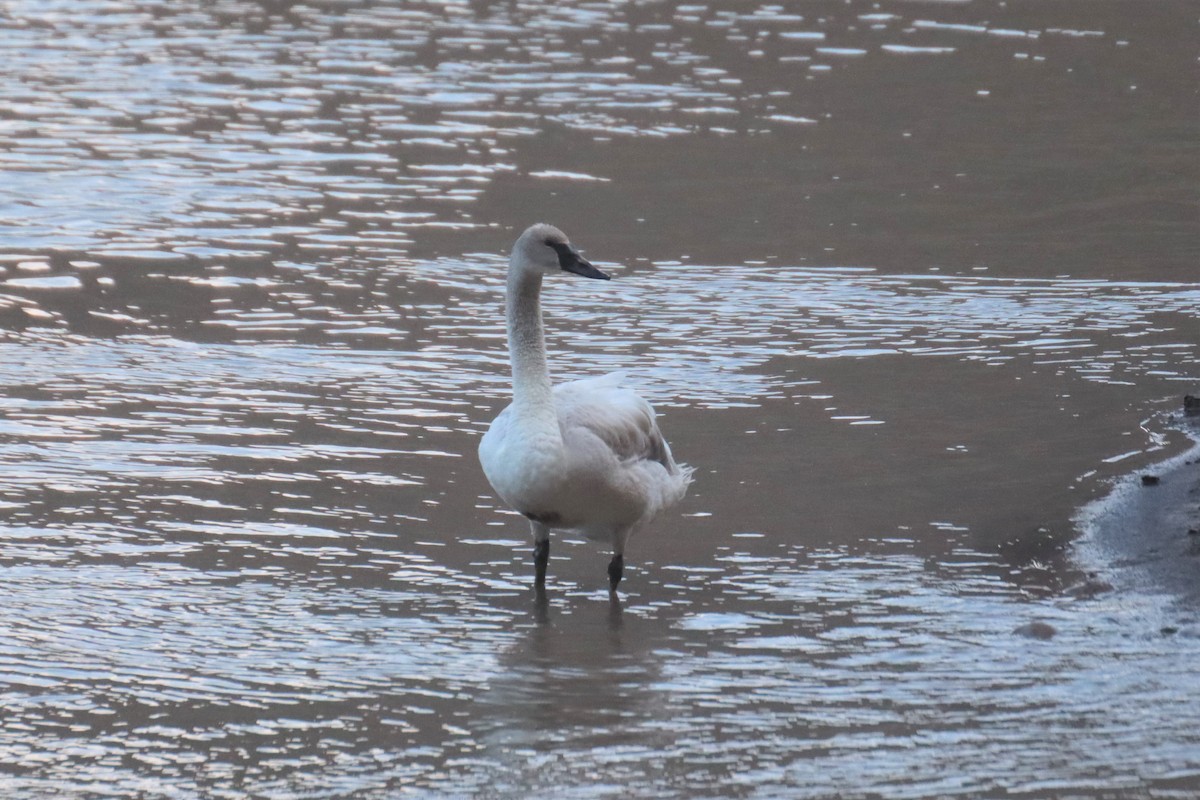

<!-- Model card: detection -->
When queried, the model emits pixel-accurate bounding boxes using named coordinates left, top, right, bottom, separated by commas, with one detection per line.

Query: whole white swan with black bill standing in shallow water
left=479, top=224, right=692, bottom=593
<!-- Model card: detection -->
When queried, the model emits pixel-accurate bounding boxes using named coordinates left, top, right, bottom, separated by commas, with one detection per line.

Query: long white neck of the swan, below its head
left=505, top=263, right=559, bottom=438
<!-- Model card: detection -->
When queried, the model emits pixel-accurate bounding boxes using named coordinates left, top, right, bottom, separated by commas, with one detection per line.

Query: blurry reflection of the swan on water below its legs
left=469, top=599, right=679, bottom=796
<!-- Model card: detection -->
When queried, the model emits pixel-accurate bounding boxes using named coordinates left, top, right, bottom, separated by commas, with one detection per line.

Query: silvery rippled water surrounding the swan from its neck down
left=0, top=268, right=1198, bottom=796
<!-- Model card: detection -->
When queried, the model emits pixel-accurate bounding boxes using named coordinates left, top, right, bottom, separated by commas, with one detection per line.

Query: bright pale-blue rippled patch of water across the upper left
left=0, top=0, right=1123, bottom=265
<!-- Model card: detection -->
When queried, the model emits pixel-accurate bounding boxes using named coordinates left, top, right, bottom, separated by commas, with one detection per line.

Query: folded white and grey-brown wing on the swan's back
left=554, top=372, right=676, bottom=471
